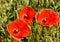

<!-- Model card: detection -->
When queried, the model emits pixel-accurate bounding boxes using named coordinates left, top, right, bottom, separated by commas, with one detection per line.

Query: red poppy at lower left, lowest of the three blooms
left=7, top=20, right=30, bottom=40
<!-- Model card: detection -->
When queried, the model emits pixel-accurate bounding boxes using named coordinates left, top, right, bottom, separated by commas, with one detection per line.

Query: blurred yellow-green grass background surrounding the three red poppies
left=0, top=0, right=60, bottom=42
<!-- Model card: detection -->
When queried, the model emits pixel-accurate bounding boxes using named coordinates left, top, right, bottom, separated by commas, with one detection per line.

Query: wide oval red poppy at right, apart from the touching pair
left=35, top=9, right=59, bottom=26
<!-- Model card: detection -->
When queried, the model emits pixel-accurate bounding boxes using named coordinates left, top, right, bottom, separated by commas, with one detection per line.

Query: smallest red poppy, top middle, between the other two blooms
left=18, top=6, right=35, bottom=23
